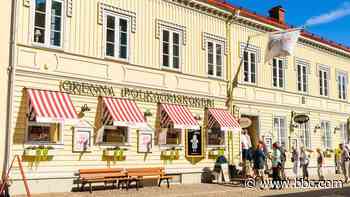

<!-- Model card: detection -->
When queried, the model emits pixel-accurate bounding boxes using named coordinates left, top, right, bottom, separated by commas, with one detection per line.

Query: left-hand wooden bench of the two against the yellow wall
left=77, top=168, right=128, bottom=193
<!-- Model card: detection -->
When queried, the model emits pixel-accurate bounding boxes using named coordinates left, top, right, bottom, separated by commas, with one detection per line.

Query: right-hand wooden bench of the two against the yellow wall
left=126, top=167, right=172, bottom=189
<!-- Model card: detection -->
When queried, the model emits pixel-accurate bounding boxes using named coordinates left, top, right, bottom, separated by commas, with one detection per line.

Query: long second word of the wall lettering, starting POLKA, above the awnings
left=121, top=88, right=214, bottom=108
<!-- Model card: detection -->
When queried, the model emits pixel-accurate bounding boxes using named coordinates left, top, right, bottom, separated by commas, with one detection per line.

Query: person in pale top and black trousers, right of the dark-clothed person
left=271, top=143, right=281, bottom=189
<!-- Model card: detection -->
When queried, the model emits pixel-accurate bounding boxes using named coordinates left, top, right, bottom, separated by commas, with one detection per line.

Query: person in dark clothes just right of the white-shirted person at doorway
left=253, top=143, right=266, bottom=188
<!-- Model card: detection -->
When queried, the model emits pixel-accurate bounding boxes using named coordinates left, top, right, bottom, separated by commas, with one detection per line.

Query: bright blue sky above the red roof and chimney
left=226, top=0, right=350, bottom=46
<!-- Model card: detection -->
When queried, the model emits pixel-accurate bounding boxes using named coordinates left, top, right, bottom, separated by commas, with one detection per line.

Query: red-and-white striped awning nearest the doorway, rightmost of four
left=208, top=108, right=241, bottom=131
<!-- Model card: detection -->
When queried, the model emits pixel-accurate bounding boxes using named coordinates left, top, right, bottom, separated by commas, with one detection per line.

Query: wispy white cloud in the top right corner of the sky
left=305, top=2, right=350, bottom=26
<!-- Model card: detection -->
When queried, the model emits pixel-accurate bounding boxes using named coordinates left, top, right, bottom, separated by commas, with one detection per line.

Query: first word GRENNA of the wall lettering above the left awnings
left=60, top=80, right=115, bottom=96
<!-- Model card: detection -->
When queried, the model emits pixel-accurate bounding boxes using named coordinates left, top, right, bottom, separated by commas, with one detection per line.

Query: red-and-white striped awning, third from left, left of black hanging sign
left=160, top=104, right=200, bottom=129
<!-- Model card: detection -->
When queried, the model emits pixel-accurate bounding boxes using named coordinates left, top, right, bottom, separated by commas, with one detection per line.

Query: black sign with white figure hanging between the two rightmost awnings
left=186, top=129, right=204, bottom=157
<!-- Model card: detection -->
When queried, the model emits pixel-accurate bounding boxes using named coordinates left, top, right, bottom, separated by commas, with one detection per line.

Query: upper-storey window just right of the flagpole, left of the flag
left=243, top=51, right=256, bottom=83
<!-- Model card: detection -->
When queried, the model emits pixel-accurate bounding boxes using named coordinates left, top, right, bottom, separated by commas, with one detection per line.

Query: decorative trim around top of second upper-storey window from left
left=97, top=2, right=136, bottom=33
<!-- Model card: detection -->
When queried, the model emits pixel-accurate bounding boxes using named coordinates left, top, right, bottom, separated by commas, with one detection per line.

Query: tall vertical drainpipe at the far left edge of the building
left=2, top=0, right=17, bottom=180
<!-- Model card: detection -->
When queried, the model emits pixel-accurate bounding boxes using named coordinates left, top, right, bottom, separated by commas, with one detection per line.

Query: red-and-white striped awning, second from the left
left=102, top=97, right=147, bottom=128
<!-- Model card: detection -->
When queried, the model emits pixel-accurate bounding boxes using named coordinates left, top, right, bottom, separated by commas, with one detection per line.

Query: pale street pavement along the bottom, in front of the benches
left=13, top=184, right=350, bottom=197
